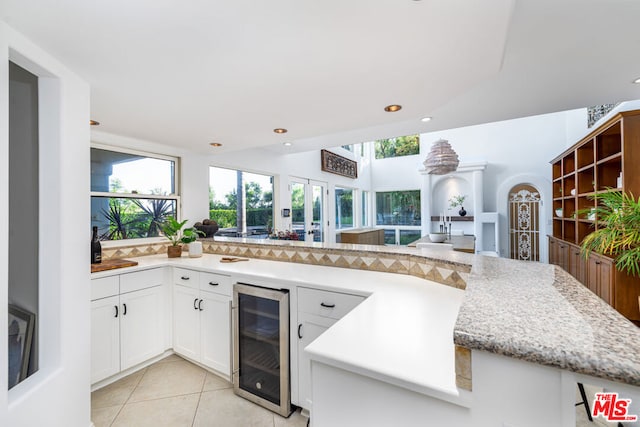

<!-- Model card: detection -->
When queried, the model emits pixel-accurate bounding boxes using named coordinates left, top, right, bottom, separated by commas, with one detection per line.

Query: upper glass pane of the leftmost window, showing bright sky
left=91, top=148, right=175, bottom=196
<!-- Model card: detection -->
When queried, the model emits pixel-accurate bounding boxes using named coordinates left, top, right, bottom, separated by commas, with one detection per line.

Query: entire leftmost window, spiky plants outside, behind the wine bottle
left=91, top=148, right=179, bottom=240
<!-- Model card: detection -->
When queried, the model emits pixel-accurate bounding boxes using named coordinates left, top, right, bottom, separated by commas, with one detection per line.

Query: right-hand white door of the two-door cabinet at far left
left=120, top=286, right=164, bottom=370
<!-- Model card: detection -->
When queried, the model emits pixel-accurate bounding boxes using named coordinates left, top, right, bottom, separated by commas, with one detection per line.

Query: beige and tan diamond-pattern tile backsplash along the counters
left=102, top=240, right=471, bottom=289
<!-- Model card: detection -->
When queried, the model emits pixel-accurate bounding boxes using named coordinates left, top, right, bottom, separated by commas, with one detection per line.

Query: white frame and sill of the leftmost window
left=89, top=141, right=182, bottom=247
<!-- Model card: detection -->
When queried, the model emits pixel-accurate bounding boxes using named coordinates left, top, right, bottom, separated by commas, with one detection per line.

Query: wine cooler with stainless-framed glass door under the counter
left=233, top=283, right=291, bottom=417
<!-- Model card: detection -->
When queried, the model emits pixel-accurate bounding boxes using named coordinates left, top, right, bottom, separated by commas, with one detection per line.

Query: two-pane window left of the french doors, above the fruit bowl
left=209, top=167, right=273, bottom=239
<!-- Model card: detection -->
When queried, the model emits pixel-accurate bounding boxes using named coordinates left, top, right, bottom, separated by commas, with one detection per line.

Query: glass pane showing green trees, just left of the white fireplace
left=376, top=190, right=420, bottom=225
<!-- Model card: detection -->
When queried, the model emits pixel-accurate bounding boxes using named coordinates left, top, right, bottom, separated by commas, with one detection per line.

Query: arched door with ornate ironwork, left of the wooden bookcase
left=509, top=184, right=540, bottom=261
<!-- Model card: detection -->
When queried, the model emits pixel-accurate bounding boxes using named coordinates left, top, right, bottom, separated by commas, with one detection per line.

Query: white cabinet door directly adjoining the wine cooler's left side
left=198, top=291, right=231, bottom=377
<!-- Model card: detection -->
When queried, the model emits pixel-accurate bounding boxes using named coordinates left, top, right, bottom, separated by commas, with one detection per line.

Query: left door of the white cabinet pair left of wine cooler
left=173, top=285, right=200, bottom=360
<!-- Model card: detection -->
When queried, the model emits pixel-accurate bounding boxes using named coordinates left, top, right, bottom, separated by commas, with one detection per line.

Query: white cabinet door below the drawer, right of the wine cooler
left=297, top=313, right=337, bottom=411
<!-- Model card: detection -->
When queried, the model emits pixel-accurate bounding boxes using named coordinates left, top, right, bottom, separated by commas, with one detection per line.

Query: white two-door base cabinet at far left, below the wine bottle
left=91, top=268, right=166, bottom=384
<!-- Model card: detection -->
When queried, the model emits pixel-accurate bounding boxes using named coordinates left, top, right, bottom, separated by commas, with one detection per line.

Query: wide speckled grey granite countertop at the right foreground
left=453, top=256, right=640, bottom=386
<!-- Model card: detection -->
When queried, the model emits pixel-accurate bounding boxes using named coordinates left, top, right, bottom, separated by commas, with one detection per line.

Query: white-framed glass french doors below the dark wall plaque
left=290, top=178, right=327, bottom=242
